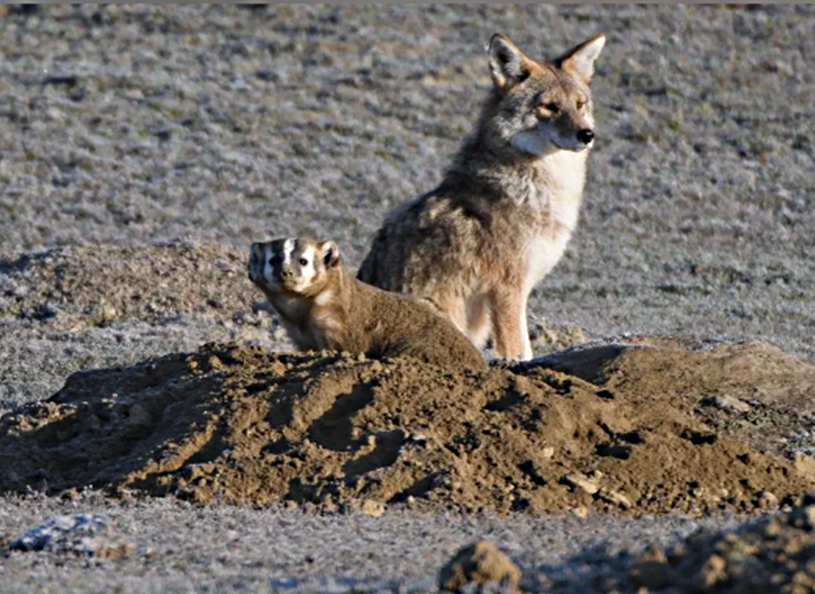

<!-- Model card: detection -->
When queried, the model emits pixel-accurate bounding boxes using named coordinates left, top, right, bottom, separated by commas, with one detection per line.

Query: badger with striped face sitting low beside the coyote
left=249, top=238, right=487, bottom=369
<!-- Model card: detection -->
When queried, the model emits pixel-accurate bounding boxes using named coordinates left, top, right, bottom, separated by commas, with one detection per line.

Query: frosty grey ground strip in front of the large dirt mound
left=0, top=494, right=736, bottom=594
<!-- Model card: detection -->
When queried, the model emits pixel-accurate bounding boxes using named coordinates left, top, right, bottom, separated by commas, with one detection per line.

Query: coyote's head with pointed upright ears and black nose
left=481, top=34, right=606, bottom=157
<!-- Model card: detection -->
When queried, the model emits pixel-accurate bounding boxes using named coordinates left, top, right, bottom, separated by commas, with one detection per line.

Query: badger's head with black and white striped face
left=249, top=238, right=339, bottom=294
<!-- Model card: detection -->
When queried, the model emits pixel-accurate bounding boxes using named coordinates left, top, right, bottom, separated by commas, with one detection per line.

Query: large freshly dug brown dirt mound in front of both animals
left=0, top=343, right=815, bottom=514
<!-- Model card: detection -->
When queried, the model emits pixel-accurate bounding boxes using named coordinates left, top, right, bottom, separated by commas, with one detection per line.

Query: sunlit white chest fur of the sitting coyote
left=524, top=151, right=586, bottom=295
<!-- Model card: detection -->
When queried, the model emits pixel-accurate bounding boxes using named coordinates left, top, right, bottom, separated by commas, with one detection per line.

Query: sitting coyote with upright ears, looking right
left=358, top=34, right=605, bottom=360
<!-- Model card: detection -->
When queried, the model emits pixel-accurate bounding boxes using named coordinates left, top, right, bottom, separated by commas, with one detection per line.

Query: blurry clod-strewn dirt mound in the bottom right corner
left=629, top=496, right=815, bottom=594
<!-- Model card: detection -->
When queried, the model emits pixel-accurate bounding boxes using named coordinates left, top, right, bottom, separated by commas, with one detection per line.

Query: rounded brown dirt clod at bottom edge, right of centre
left=439, top=540, right=521, bottom=592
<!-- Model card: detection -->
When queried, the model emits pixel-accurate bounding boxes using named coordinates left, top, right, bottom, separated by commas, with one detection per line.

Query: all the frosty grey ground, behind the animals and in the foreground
left=0, top=5, right=815, bottom=592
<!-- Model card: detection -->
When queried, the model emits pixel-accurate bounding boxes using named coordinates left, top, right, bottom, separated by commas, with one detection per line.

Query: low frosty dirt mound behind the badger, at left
left=0, top=241, right=264, bottom=327
